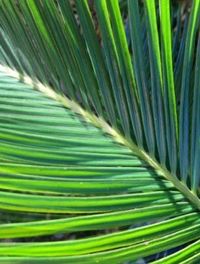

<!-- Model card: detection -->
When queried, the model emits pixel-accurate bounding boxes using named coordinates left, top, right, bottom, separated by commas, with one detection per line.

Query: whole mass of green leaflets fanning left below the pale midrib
left=0, top=73, right=200, bottom=263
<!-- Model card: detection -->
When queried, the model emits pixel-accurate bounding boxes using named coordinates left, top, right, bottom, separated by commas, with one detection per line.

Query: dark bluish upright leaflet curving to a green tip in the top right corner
left=180, top=1, right=200, bottom=186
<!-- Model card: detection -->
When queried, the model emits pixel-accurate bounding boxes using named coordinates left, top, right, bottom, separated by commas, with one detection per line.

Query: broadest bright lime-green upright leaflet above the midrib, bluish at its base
left=159, top=0, right=178, bottom=173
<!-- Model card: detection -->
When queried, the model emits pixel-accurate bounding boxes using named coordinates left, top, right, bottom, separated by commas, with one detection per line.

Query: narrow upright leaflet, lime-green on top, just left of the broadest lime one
left=144, top=0, right=166, bottom=164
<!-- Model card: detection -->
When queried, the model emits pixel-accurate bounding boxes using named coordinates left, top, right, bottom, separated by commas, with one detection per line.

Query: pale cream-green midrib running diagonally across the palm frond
left=0, top=64, right=200, bottom=210
